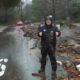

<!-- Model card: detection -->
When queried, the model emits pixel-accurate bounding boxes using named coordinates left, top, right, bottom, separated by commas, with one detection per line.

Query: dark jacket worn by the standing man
left=39, top=26, right=61, bottom=47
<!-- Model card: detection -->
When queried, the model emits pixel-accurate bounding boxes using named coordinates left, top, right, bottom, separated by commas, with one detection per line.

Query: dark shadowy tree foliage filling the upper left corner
left=0, top=0, right=21, bottom=24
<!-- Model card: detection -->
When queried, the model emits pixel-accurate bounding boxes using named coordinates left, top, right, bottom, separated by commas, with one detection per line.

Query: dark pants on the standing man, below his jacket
left=41, top=46, right=57, bottom=72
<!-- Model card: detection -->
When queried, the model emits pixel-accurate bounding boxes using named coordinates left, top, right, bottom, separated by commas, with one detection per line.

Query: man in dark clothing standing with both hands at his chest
left=38, top=16, right=60, bottom=79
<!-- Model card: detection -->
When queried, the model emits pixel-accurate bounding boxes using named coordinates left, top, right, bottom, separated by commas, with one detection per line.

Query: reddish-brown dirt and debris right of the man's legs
left=57, top=36, right=80, bottom=80
